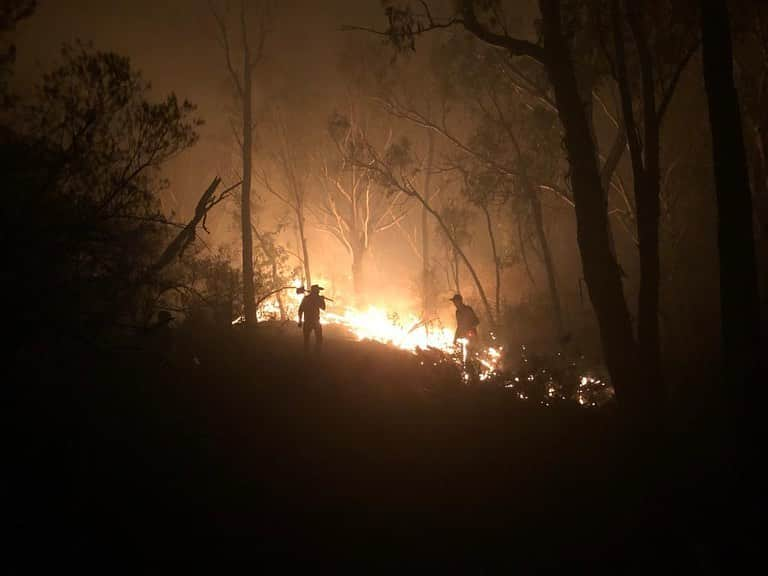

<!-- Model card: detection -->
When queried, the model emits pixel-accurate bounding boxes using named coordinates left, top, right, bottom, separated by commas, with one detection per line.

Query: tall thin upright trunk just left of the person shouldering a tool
left=209, top=0, right=270, bottom=323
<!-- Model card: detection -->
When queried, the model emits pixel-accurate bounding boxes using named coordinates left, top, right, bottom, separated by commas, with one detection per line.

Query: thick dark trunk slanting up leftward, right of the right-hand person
left=539, top=0, right=646, bottom=413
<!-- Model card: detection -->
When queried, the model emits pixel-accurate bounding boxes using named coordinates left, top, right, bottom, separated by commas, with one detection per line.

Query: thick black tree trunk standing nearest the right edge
left=700, top=0, right=760, bottom=420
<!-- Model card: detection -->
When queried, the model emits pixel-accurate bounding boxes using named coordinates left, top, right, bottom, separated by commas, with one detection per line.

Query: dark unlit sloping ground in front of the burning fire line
left=9, top=327, right=748, bottom=574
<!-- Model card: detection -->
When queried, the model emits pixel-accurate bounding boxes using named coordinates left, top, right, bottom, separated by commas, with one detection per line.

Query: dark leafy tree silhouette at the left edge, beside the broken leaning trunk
left=2, top=44, right=201, bottom=348
